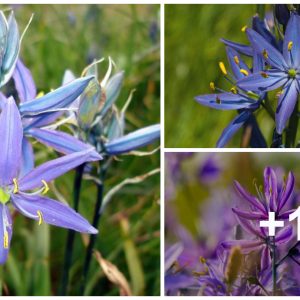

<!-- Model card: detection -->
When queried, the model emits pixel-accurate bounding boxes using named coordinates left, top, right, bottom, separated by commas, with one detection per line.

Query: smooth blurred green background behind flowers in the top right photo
left=165, top=4, right=275, bottom=148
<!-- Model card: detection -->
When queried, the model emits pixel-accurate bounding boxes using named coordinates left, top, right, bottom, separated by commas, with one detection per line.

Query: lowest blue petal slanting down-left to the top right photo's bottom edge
left=217, top=110, right=251, bottom=148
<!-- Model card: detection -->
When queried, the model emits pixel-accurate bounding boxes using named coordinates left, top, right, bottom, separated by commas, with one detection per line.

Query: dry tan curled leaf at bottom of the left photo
left=94, top=251, right=132, bottom=296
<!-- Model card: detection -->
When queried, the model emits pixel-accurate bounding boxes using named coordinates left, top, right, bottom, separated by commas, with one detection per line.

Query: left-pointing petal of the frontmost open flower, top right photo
left=237, top=71, right=288, bottom=92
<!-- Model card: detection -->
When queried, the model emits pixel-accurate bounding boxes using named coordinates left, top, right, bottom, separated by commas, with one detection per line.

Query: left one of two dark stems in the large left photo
left=59, top=163, right=85, bottom=296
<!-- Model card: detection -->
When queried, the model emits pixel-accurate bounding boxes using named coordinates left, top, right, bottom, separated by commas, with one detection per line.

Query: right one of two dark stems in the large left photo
left=80, top=162, right=106, bottom=295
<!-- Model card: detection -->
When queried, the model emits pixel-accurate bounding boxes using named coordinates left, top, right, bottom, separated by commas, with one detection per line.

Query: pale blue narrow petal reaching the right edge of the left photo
left=105, top=124, right=160, bottom=155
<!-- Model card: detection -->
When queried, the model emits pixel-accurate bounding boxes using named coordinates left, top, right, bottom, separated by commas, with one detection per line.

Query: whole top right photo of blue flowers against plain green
left=165, top=4, right=300, bottom=148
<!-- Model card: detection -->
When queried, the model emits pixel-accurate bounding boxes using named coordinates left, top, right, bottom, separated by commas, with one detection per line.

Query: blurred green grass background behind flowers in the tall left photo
left=0, top=5, right=160, bottom=296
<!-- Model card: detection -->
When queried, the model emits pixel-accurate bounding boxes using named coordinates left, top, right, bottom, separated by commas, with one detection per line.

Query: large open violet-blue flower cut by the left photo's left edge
left=0, top=97, right=100, bottom=264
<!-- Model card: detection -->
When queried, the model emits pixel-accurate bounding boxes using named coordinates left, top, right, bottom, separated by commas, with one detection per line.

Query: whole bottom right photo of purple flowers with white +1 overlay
left=165, top=152, right=300, bottom=296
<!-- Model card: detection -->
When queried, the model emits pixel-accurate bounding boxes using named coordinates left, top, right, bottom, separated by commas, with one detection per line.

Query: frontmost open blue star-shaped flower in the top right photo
left=237, top=13, right=300, bottom=134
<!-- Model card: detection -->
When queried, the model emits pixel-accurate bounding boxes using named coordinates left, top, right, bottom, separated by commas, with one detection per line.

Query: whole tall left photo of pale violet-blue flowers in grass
left=0, top=4, right=160, bottom=296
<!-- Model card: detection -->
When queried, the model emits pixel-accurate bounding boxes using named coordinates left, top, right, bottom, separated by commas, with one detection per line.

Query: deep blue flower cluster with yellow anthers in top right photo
left=196, top=5, right=300, bottom=147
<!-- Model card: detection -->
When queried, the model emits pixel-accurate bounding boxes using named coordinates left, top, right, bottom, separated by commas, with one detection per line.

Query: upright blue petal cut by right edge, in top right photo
left=282, top=13, right=300, bottom=67
